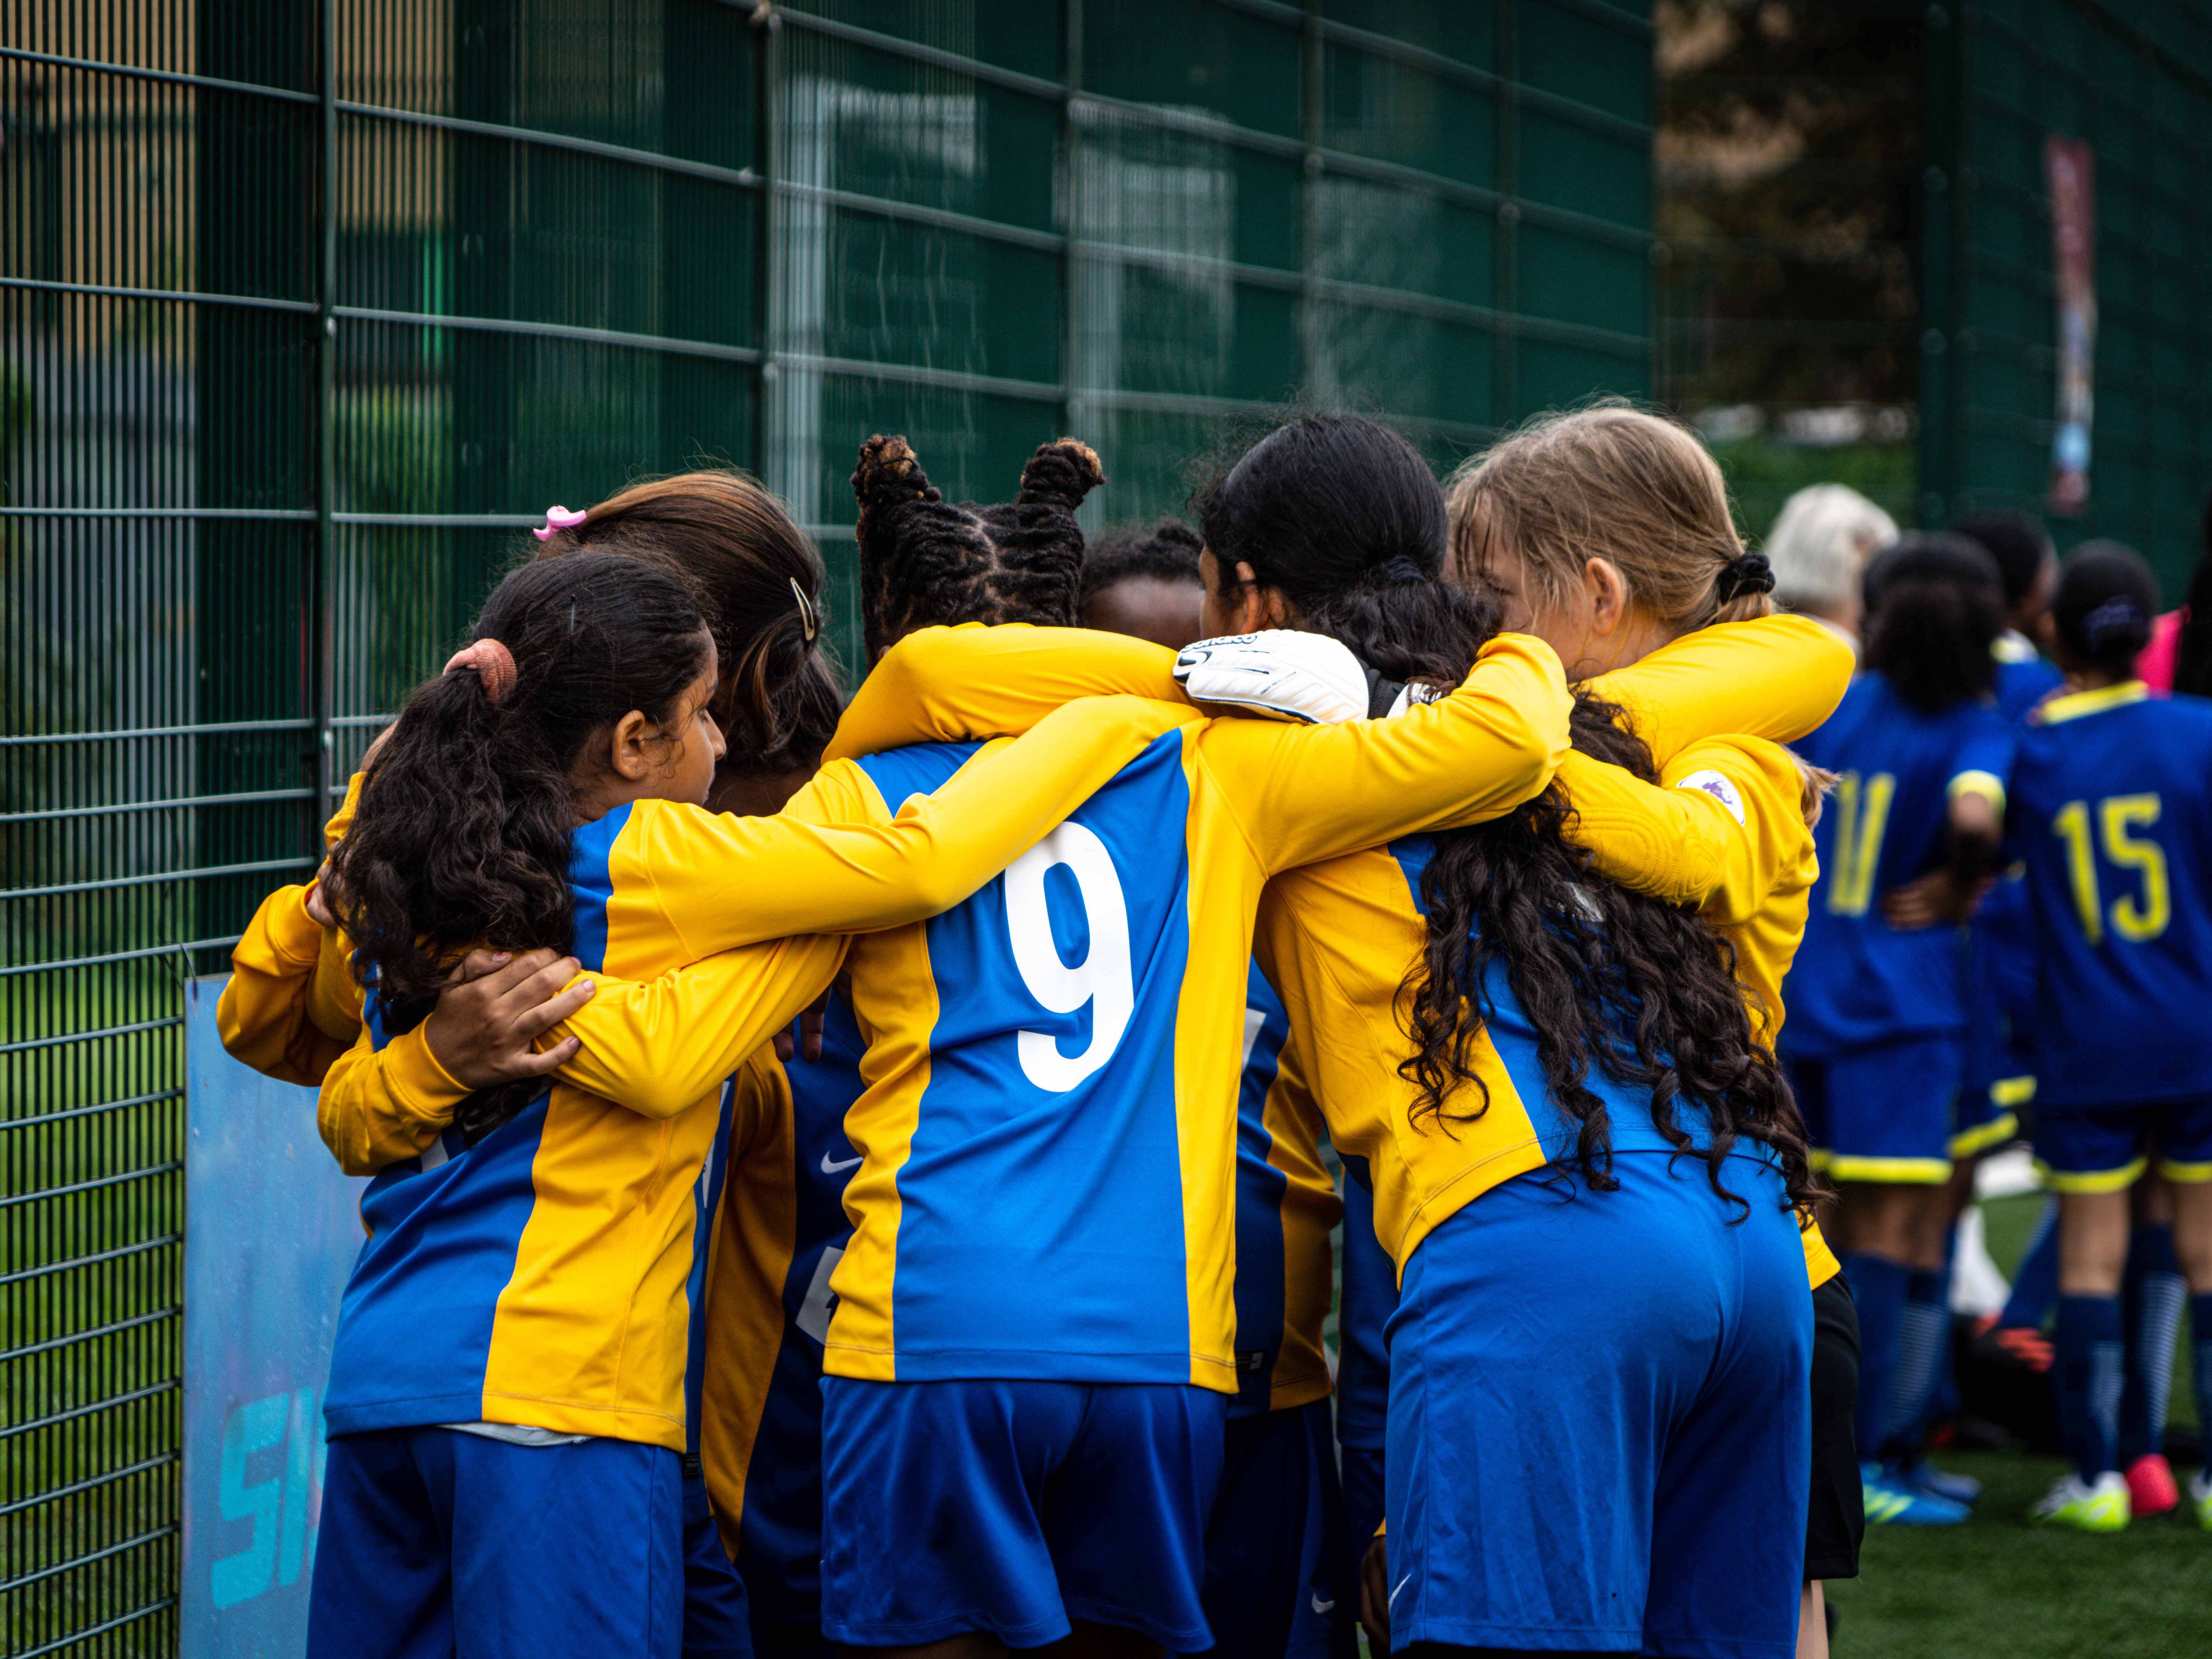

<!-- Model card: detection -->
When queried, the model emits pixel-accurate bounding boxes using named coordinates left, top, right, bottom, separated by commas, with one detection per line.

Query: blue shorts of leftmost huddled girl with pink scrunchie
left=308, top=1429, right=683, bottom=1659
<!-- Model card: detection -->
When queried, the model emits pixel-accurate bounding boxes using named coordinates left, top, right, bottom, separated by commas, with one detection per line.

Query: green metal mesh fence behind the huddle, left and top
left=0, top=0, right=1650, bottom=1655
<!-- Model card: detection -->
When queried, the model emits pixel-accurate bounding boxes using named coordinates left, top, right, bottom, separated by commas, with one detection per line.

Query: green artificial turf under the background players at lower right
left=1827, top=1451, right=2212, bottom=1659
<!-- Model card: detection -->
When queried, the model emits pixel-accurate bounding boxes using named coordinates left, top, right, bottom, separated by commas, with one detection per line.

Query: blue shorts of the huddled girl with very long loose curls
left=1385, top=1153, right=1812, bottom=1659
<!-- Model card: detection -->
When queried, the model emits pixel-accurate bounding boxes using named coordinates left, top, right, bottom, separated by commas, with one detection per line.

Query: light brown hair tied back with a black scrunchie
left=1444, top=400, right=1774, bottom=632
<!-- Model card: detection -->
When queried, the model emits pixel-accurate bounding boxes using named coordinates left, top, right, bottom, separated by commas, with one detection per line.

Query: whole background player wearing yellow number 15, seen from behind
left=2011, top=549, right=2212, bottom=1531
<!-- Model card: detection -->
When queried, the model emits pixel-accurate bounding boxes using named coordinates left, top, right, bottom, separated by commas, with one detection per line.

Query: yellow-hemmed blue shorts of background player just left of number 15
left=1783, top=1038, right=1967, bottom=1185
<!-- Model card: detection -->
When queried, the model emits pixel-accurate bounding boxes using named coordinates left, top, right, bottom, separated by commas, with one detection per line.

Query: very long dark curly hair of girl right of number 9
left=1199, top=416, right=1816, bottom=1212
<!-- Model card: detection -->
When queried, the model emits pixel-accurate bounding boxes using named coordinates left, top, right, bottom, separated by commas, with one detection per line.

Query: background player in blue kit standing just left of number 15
left=1783, top=535, right=2013, bottom=1524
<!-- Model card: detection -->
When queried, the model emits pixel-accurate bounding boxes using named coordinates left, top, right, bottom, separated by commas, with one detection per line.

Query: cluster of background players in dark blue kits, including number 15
left=1783, top=517, right=2212, bottom=1533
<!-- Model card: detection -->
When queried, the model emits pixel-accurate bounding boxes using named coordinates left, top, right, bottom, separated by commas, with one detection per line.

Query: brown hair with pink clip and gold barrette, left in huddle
left=535, top=467, right=823, bottom=763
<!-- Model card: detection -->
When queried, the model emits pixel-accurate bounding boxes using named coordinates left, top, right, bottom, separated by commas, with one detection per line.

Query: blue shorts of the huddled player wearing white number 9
left=823, top=1376, right=1230, bottom=1652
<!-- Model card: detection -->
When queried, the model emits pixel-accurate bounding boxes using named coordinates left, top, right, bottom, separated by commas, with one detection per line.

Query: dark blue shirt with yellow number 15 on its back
left=2011, top=681, right=2212, bottom=1115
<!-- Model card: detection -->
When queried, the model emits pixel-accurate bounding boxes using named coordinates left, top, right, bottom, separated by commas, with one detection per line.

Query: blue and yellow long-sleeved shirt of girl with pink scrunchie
left=301, top=699, right=1190, bottom=1449
